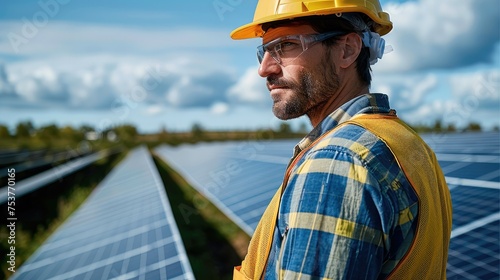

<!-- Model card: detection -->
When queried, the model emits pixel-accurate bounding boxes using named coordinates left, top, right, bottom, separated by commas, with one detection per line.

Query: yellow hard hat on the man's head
left=231, top=0, right=392, bottom=39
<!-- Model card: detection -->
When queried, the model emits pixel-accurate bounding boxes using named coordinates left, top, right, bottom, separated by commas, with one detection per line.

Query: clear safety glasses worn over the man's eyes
left=257, top=31, right=346, bottom=65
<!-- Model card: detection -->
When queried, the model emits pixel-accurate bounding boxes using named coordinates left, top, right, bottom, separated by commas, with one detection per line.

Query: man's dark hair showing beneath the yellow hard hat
left=262, top=13, right=373, bottom=86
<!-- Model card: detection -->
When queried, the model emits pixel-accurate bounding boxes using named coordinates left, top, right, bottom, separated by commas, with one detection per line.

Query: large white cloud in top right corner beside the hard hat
left=374, top=0, right=500, bottom=72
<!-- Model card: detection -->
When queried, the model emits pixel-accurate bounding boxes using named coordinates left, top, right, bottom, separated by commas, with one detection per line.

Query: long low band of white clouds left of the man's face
left=0, top=56, right=242, bottom=110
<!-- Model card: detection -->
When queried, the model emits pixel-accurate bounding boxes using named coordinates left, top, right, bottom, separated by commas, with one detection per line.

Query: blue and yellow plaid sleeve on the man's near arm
left=275, top=145, right=397, bottom=279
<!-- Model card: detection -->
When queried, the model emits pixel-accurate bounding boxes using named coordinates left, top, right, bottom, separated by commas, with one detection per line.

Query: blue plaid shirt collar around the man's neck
left=294, top=93, right=391, bottom=156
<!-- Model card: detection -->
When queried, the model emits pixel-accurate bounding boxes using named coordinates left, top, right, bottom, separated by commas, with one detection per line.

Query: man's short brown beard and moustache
left=267, top=54, right=340, bottom=120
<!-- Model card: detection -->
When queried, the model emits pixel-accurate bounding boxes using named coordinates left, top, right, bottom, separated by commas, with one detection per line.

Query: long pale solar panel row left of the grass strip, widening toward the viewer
left=13, top=147, right=194, bottom=280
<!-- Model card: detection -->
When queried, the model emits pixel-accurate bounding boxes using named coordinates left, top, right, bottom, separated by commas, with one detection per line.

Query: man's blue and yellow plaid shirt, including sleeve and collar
left=265, top=94, right=418, bottom=279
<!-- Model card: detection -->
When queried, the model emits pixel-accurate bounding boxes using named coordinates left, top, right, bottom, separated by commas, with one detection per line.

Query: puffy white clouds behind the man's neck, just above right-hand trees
left=372, top=68, right=500, bottom=127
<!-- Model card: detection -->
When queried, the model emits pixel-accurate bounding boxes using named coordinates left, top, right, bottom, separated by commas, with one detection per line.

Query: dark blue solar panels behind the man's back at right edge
left=424, top=133, right=500, bottom=279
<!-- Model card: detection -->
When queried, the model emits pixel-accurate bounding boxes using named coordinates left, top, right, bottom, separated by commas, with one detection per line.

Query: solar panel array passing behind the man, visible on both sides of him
left=155, top=132, right=500, bottom=279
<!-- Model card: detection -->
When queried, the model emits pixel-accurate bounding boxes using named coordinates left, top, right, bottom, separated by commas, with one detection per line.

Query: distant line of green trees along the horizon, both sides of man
left=0, top=120, right=500, bottom=151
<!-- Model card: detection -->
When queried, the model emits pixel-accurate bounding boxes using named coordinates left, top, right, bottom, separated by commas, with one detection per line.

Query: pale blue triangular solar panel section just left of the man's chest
left=155, top=140, right=296, bottom=235
